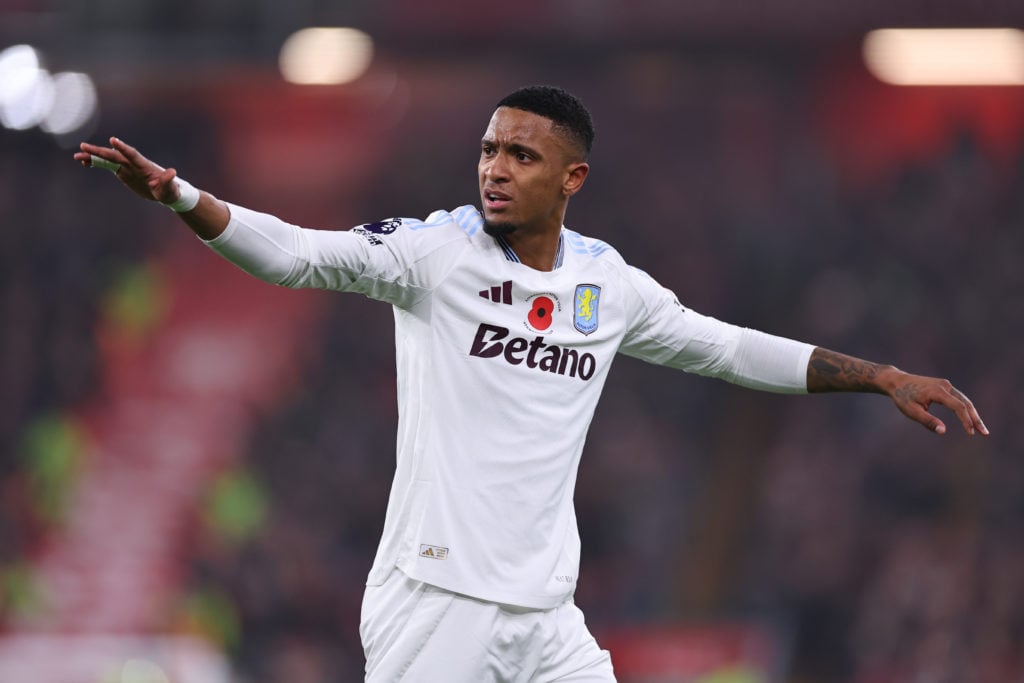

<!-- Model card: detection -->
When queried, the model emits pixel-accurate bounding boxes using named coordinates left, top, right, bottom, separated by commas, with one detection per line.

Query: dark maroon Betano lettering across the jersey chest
left=469, top=323, right=597, bottom=381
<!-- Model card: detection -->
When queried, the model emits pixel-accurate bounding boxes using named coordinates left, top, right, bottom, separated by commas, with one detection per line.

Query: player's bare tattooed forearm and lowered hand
left=807, top=347, right=988, bottom=436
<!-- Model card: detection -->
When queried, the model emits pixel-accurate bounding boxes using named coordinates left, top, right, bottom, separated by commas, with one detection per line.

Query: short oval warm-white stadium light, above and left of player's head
left=279, top=28, right=374, bottom=85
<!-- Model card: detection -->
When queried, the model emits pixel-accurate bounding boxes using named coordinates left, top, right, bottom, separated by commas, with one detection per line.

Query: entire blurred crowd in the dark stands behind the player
left=0, top=54, right=1024, bottom=683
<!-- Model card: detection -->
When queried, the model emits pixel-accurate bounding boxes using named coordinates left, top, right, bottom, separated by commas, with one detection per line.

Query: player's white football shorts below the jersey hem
left=359, top=569, right=615, bottom=683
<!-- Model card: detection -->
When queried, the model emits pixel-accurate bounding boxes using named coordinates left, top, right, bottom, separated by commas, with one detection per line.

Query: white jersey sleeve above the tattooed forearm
left=621, top=270, right=814, bottom=393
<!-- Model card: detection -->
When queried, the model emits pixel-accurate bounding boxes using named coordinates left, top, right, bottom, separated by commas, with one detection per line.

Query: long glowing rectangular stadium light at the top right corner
left=863, top=29, right=1024, bottom=85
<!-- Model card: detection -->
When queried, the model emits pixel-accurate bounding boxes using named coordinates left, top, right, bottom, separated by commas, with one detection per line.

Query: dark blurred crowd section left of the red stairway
left=0, top=124, right=158, bottom=581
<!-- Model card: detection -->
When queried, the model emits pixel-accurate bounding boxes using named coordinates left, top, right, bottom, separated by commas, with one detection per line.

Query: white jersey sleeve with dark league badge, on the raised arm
left=205, top=204, right=462, bottom=306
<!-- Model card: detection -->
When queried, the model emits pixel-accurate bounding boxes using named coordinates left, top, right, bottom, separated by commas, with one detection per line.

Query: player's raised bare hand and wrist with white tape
left=75, top=137, right=231, bottom=240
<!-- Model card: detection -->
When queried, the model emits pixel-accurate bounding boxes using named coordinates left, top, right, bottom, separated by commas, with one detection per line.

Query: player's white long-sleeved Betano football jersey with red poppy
left=208, top=205, right=813, bottom=608
